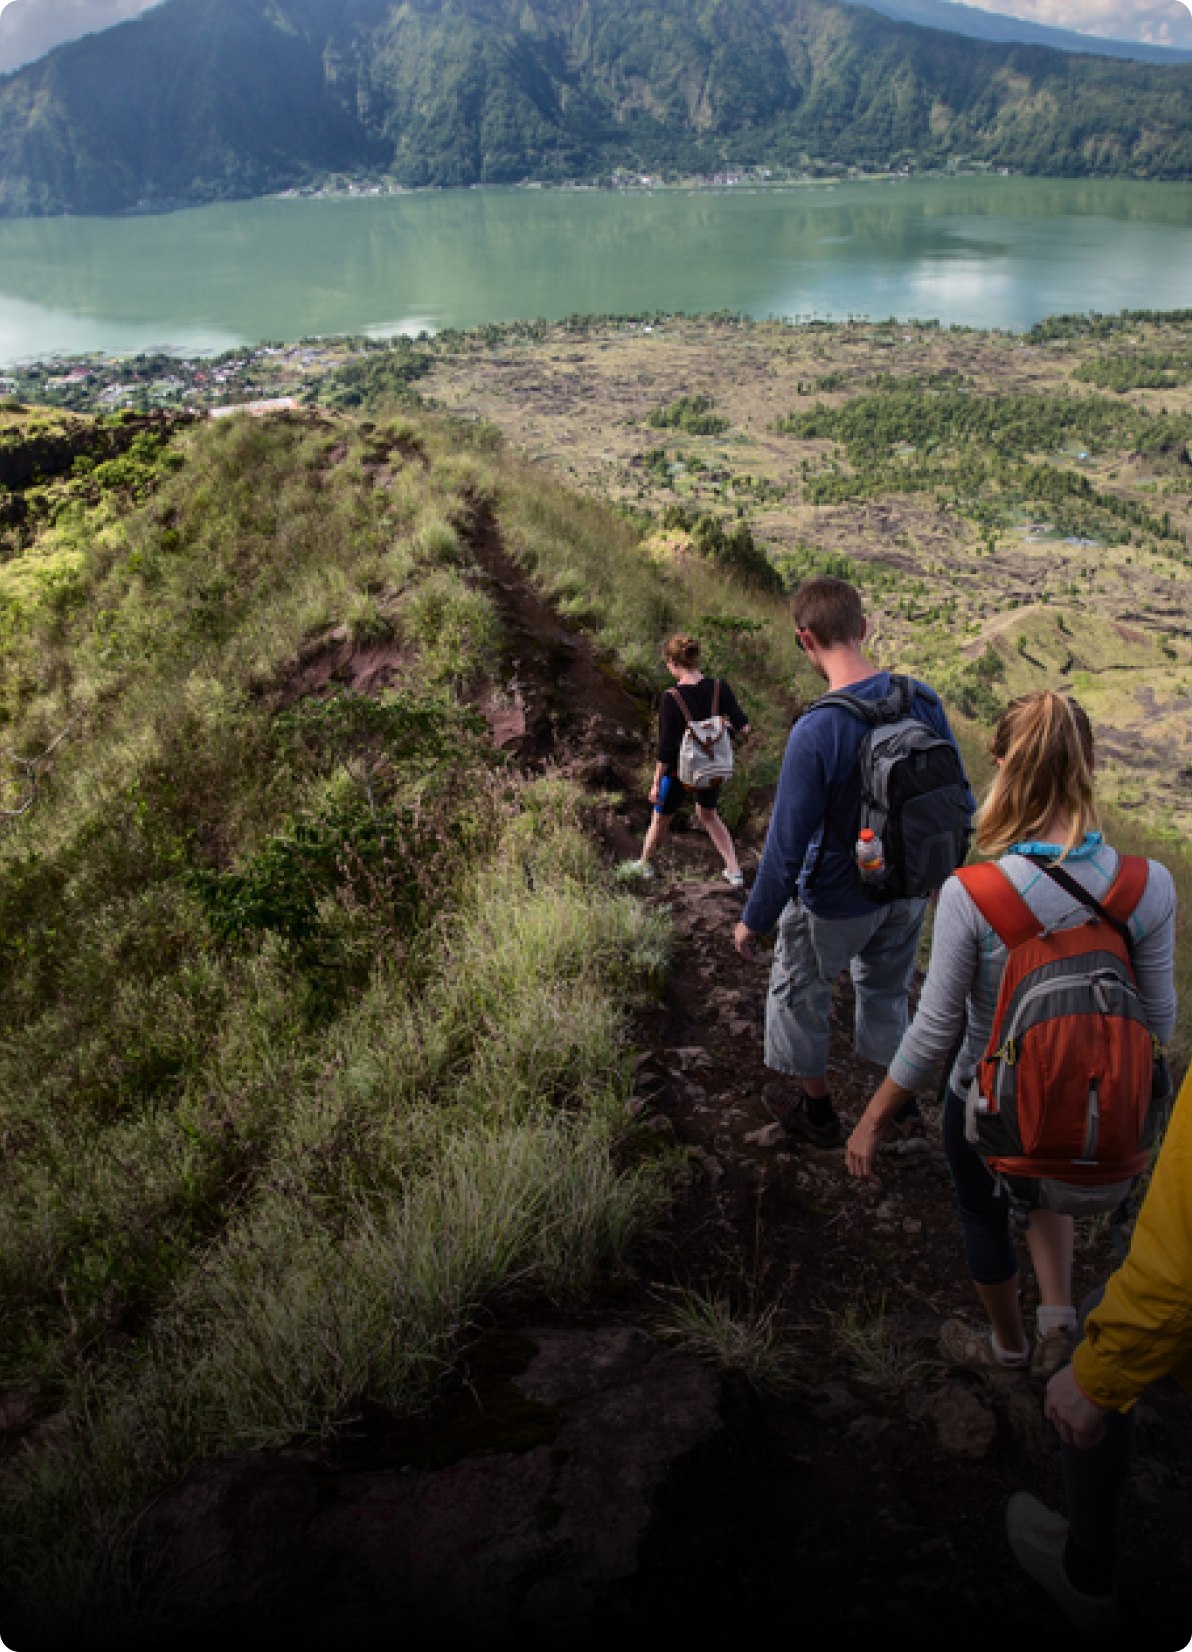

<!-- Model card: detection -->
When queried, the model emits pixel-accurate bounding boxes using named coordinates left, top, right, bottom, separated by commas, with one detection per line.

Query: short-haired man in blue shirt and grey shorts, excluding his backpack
left=735, top=578, right=956, bottom=1146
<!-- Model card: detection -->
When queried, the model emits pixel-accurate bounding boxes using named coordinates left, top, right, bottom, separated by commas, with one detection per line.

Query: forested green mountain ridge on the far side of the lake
left=0, top=0, right=1192, bottom=216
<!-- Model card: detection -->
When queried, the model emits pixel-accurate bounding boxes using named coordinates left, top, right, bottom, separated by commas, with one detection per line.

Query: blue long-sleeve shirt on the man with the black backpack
left=743, top=671, right=976, bottom=935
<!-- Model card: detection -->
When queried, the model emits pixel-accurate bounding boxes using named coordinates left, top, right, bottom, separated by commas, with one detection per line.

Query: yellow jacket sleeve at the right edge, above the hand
left=1071, top=1067, right=1192, bottom=1411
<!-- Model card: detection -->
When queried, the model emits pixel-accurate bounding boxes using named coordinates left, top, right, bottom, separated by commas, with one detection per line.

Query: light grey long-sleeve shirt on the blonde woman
left=890, top=839, right=1175, bottom=1094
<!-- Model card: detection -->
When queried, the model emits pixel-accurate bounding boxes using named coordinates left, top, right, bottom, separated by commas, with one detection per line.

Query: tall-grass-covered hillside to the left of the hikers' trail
left=0, top=399, right=696, bottom=1644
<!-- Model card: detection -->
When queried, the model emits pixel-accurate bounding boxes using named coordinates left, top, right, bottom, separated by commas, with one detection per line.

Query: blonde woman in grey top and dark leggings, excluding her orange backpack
left=847, top=691, right=1175, bottom=1376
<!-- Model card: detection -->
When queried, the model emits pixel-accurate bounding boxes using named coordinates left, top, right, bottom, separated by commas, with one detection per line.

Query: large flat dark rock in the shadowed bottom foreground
left=123, top=1327, right=720, bottom=1647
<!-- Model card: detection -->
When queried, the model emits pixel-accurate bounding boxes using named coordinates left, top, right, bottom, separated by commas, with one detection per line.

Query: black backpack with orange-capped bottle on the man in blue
left=809, top=677, right=972, bottom=905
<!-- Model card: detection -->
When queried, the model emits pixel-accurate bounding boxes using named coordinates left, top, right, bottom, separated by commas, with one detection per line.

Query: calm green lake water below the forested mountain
left=0, top=178, right=1192, bottom=362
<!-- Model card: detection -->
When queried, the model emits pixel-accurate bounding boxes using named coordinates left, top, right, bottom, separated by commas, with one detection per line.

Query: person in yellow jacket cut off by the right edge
left=1005, top=1069, right=1192, bottom=1632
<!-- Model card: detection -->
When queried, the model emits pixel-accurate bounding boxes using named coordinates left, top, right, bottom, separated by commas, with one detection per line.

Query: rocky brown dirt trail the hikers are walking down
left=465, top=508, right=1192, bottom=1647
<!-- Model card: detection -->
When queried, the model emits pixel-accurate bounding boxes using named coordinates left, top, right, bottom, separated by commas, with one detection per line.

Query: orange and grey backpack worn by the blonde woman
left=956, top=856, right=1162, bottom=1216
